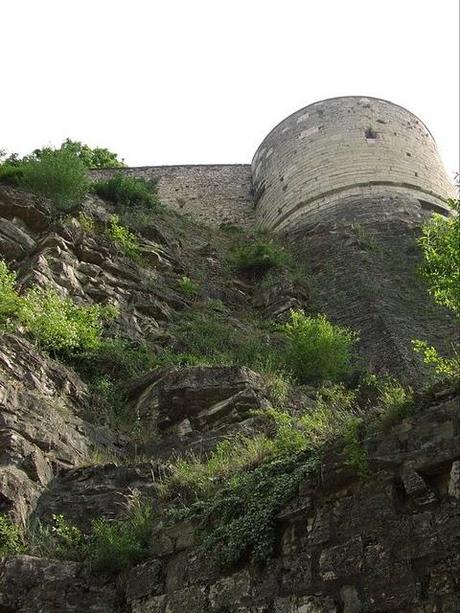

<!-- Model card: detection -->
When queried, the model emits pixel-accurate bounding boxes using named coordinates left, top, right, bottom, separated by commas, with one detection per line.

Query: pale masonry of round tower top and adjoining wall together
left=88, top=96, right=454, bottom=233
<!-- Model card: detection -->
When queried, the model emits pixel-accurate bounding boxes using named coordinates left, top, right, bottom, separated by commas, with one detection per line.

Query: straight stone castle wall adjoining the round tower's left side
left=91, top=164, right=254, bottom=227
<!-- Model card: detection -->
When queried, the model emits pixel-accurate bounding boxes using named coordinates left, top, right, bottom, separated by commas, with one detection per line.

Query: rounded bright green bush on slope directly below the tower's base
left=281, top=310, right=358, bottom=383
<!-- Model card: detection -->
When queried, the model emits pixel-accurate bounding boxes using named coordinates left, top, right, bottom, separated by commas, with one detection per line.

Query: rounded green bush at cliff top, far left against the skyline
left=19, top=149, right=89, bottom=211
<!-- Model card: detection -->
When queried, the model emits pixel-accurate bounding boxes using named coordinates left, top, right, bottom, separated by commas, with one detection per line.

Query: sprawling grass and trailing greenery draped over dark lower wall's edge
left=162, top=386, right=368, bottom=566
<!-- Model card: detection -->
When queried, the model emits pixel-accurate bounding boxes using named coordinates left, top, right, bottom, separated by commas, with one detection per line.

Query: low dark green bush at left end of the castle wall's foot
left=92, top=172, right=159, bottom=208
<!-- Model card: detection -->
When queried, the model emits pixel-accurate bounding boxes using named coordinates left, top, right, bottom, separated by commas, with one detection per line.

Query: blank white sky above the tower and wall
left=0, top=0, right=459, bottom=176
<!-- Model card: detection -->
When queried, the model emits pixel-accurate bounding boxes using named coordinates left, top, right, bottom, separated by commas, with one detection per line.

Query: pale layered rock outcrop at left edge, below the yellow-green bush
left=0, top=334, right=114, bottom=521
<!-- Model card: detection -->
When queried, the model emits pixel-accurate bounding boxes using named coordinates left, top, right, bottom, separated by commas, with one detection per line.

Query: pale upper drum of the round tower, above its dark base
left=252, top=96, right=454, bottom=232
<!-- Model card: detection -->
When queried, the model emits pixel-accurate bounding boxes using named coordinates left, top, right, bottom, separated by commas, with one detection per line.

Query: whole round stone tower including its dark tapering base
left=252, top=96, right=456, bottom=382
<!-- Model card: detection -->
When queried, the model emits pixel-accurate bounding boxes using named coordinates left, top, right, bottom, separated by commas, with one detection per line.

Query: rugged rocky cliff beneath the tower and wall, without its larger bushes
left=0, top=187, right=460, bottom=613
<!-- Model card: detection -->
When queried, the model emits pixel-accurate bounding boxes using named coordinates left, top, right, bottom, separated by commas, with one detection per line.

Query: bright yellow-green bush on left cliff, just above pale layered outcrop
left=17, top=288, right=116, bottom=354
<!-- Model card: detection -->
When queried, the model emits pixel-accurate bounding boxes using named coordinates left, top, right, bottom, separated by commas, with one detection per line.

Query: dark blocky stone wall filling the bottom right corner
left=126, top=397, right=460, bottom=613
